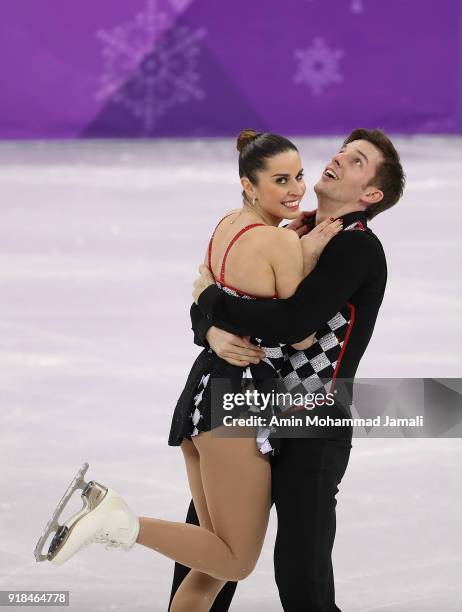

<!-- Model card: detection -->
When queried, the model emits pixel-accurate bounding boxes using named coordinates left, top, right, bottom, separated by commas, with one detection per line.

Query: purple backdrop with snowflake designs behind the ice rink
left=0, top=0, right=462, bottom=138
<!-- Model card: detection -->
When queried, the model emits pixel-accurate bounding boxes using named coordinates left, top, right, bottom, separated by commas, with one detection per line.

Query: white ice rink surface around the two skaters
left=0, top=137, right=462, bottom=612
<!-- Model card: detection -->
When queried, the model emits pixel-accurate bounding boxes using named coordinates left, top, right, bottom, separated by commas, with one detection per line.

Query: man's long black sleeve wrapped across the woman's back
left=199, top=230, right=383, bottom=344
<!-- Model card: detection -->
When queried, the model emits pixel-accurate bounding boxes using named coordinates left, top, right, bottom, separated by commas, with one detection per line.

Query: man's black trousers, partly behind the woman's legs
left=169, top=438, right=352, bottom=612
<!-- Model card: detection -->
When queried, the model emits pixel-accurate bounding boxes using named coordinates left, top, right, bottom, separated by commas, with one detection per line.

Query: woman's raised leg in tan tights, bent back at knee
left=137, top=432, right=271, bottom=580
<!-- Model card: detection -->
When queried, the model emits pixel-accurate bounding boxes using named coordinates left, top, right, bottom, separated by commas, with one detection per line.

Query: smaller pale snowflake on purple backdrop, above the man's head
left=294, top=37, right=343, bottom=96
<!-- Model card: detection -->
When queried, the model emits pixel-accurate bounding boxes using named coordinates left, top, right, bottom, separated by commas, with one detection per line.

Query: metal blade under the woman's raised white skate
left=34, top=463, right=107, bottom=562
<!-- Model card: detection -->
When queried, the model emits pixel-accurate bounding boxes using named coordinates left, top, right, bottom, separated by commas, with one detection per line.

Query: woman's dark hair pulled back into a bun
left=236, top=129, right=298, bottom=198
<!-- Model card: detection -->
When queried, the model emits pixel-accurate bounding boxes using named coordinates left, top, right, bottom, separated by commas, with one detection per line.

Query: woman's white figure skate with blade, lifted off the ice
left=35, top=463, right=139, bottom=565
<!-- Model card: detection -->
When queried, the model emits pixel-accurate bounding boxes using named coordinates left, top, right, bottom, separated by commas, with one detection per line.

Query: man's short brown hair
left=343, top=128, right=406, bottom=219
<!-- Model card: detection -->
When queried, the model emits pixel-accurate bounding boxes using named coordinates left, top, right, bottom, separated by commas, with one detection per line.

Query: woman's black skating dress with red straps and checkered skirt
left=168, top=215, right=285, bottom=454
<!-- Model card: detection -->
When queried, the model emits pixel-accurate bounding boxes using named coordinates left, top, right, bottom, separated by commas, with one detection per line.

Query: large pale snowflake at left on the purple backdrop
left=96, top=0, right=205, bottom=133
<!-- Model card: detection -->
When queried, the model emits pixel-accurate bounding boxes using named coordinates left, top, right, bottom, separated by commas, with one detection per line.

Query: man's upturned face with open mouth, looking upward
left=314, top=140, right=383, bottom=206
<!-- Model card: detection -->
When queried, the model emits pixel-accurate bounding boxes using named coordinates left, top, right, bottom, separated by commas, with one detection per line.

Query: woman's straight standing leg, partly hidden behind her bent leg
left=169, top=439, right=226, bottom=612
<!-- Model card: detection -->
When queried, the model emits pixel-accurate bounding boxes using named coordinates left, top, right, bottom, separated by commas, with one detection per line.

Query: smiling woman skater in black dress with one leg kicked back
left=36, top=130, right=341, bottom=612
